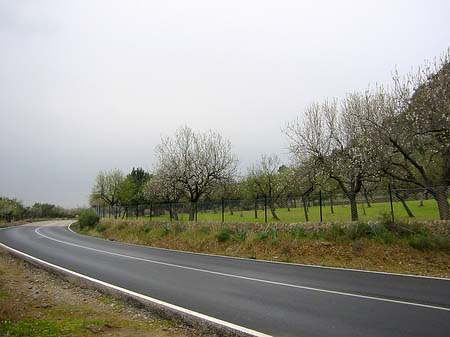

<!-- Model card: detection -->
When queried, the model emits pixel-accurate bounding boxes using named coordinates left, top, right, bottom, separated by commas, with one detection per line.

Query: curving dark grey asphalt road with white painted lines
left=0, top=222, right=450, bottom=337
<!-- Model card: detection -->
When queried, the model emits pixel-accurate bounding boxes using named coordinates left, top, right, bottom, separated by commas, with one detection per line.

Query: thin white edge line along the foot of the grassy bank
left=67, top=222, right=450, bottom=281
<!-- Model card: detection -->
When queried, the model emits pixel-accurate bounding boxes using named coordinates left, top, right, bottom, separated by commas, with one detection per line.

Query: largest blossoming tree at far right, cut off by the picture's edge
left=354, top=50, right=450, bottom=219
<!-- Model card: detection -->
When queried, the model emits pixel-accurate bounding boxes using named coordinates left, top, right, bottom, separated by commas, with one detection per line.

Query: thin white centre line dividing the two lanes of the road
left=34, top=227, right=450, bottom=311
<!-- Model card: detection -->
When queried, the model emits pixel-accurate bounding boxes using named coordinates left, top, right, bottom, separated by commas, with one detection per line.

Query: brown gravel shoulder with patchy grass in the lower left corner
left=0, top=249, right=199, bottom=337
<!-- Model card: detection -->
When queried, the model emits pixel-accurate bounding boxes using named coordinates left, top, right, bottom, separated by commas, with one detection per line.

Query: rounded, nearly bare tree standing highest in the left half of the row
left=156, top=126, right=237, bottom=221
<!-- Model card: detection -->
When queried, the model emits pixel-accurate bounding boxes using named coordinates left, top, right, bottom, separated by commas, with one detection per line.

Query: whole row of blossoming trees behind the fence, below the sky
left=90, top=51, right=450, bottom=220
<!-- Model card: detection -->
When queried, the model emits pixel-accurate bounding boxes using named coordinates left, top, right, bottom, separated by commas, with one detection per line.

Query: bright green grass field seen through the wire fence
left=113, top=199, right=446, bottom=223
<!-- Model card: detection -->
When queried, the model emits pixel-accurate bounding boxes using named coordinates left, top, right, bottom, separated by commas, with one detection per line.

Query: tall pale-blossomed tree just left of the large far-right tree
left=284, top=95, right=374, bottom=221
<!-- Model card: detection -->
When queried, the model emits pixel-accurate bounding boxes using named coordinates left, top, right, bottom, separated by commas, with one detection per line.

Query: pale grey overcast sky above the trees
left=0, top=0, right=450, bottom=207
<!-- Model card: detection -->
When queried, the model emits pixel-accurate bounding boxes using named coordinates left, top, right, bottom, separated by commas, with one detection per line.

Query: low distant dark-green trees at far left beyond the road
left=0, top=197, right=80, bottom=222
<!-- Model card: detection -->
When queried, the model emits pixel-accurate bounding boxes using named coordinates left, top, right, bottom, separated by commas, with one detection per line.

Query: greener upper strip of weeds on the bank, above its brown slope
left=81, top=217, right=450, bottom=253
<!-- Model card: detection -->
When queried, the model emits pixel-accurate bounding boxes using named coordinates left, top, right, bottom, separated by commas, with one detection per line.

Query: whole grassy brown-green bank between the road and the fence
left=74, top=219, right=450, bottom=278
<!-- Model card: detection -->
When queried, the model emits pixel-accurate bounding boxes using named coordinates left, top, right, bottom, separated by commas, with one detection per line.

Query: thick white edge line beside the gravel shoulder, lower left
left=0, top=243, right=272, bottom=337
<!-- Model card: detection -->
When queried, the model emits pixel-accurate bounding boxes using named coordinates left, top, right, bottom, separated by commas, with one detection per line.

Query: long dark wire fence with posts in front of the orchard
left=94, top=186, right=450, bottom=223
